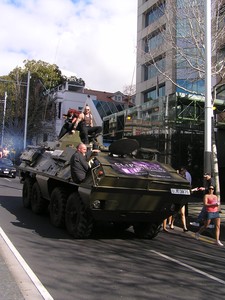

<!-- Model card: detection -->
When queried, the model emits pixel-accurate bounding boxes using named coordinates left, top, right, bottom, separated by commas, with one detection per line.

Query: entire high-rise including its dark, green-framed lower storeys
left=104, top=0, right=225, bottom=191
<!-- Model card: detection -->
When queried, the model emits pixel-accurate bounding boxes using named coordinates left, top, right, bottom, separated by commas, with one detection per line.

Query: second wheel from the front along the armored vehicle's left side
left=50, top=187, right=67, bottom=227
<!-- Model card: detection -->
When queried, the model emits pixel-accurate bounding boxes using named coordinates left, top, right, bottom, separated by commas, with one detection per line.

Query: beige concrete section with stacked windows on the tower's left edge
left=136, top=0, right=171, bottom=105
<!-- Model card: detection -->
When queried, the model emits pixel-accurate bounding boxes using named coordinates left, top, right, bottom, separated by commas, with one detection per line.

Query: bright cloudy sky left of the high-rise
left=0, top=0, right=137, bottom=92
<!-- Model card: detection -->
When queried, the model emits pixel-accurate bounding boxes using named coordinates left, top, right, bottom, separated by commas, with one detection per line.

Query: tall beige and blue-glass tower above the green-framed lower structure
left=136, top=0, right=225, bottom=104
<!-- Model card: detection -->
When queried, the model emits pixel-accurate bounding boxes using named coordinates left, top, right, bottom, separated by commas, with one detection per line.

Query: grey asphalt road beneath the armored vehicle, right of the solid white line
left=0, top=178, right=225, bottom=300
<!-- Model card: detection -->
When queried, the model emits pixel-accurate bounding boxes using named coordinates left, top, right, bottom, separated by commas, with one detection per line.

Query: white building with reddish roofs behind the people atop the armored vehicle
left=36, top=77, right=135, bottom=145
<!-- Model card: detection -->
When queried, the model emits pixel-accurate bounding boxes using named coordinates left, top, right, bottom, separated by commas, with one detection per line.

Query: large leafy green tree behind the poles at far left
left=0, top=60, right=67, bottom=157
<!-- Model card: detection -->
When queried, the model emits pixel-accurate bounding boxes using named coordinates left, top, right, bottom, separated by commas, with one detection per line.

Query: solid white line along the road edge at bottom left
left=0, top=227, right=54, bottom=300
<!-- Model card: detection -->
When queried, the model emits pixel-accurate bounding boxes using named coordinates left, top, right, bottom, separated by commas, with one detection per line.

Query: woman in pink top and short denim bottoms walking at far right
left=195, top=185, right=223, bottom=246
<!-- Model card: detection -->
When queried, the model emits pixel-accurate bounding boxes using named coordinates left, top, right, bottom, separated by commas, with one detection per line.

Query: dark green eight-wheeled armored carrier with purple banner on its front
left=18, top=134, right=190, bottom=239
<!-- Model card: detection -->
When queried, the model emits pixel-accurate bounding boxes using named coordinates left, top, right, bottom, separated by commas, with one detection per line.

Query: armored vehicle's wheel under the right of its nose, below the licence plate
left=133, top=222, right=161, bottom=239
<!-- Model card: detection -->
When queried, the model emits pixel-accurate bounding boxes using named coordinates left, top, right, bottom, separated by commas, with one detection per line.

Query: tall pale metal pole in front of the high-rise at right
left=204, top=0, right=212, bottom=174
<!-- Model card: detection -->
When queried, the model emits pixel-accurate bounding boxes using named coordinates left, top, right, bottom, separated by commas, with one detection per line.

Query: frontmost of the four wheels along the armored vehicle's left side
left=65, top=193, right=93, bottom=238
